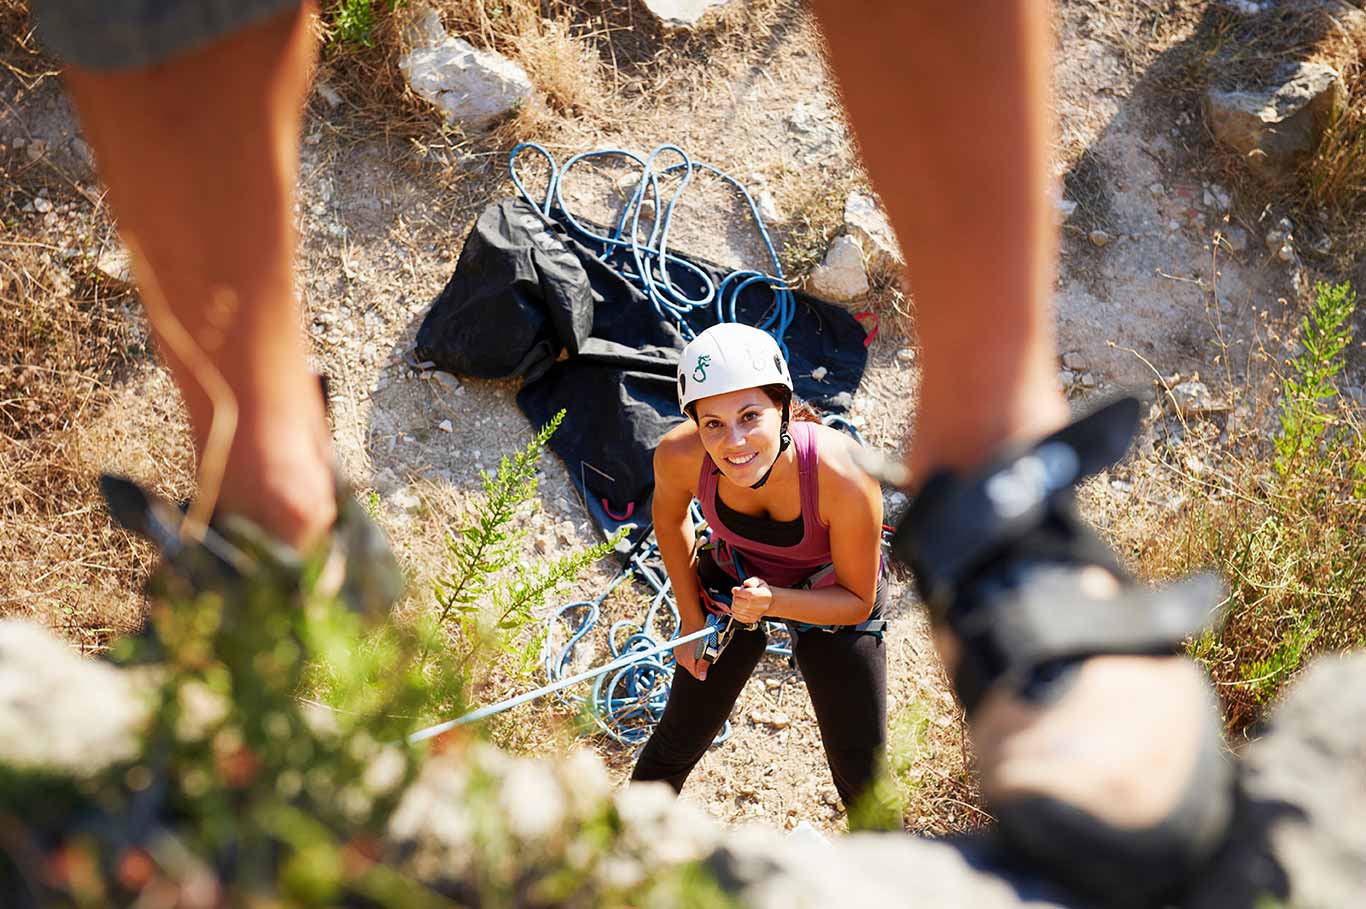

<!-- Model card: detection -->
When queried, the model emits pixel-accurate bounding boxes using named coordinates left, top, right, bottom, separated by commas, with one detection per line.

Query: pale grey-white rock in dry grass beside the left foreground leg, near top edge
left=399, top=8, right=531, bottom=128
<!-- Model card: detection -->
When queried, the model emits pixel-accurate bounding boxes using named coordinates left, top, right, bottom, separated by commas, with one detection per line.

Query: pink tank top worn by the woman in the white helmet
left=697, top=421, right=833, bottom=586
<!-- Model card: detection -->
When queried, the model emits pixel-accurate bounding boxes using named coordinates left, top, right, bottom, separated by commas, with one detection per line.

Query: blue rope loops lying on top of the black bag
left=508, top=142, right=796, bottom=357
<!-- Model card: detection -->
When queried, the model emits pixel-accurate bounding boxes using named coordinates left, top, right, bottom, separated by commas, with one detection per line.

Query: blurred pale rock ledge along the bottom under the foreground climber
left=0, top=619, right=1366, bottom=909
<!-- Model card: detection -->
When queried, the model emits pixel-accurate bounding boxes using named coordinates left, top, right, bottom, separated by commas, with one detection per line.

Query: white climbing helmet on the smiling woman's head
left=678, top=323, right=792, bottom=413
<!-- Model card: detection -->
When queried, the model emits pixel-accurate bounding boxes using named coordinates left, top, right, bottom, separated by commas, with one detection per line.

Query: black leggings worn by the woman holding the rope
left=631, top=557, right=887, bottom=806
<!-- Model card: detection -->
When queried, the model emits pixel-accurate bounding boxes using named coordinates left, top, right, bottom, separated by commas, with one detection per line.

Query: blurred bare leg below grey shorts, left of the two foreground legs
left=66, top=4, right=336, bottom=547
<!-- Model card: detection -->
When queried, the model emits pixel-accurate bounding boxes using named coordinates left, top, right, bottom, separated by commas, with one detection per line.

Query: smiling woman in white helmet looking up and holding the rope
left=631, top=324, right=887, bottom=813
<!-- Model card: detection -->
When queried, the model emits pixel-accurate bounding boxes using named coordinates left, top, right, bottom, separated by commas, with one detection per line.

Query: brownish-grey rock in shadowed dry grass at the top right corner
left=1205, top=63, right=1344, bottom=182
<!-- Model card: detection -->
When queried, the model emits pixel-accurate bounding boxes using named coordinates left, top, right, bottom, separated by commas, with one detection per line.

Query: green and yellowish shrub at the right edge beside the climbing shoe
left=1169, top=284, right=1366, bottom=729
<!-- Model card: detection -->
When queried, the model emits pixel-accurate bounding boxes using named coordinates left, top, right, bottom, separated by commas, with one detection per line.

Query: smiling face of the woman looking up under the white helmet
left=694, top=388, right=783, bottom=487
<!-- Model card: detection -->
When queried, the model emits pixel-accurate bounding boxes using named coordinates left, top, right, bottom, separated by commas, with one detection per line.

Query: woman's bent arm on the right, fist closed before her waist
left=731, top=437, right=882, bottom=625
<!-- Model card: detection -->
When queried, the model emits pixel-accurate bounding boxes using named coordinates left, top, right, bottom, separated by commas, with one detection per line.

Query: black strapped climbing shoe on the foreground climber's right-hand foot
left=892, top=398, right=1233, bottom=906
